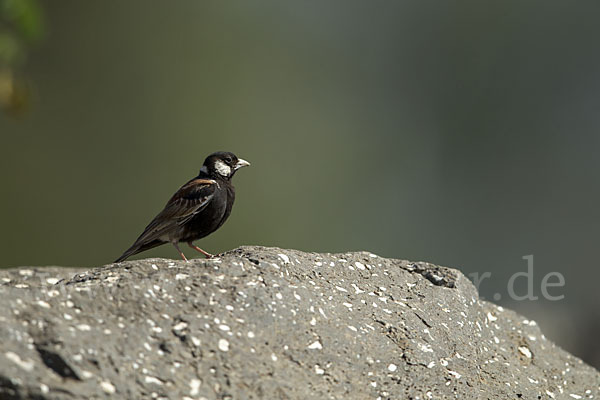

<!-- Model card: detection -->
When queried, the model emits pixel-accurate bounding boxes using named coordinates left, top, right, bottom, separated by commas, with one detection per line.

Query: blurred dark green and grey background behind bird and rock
left=0, top=0, right=600, bottom=366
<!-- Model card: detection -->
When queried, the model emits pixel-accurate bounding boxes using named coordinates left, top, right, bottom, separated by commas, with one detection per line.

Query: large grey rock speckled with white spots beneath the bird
left=0, top=247, right=600, bottom=400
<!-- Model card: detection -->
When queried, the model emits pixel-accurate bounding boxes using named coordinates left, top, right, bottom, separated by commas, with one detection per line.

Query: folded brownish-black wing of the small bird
left=129, top=178, right=219, bottom=246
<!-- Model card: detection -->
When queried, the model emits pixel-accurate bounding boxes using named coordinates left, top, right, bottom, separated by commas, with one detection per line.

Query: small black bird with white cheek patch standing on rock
left=115, top=151, right=250, bottom=262
